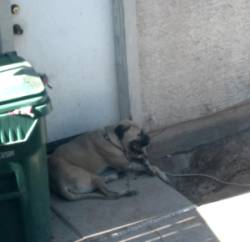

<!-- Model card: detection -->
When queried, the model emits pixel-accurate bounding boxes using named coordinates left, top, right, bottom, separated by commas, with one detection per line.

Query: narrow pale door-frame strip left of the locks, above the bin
left=0, top=0, right=14, bottom=53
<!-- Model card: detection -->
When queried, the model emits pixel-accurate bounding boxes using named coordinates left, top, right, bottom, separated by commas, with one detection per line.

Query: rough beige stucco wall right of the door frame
left=136, top=0, right=250, bottom=129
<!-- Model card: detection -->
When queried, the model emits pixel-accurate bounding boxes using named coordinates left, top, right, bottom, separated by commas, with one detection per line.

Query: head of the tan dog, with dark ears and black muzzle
left=114, top=120, right=150, bottom=159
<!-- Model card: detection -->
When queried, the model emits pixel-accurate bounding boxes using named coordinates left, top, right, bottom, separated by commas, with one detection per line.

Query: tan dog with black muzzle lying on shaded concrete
left=49, top=120, right=170, bottom=200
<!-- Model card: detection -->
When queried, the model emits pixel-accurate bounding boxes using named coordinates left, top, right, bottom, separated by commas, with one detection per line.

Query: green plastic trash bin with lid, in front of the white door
left=0, top=53, right=51, bottom=242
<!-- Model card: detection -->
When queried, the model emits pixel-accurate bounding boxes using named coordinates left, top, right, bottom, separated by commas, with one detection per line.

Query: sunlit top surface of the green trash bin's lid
left=0, top=60, right=45, bottom=105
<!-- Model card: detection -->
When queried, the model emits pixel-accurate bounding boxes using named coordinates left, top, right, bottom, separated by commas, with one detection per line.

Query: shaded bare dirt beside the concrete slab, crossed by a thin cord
left=152, top=131, right=250, bottom=205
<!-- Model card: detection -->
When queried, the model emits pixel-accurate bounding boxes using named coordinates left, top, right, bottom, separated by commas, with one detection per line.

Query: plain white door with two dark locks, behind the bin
left=13, top=0, right=119, bottom=141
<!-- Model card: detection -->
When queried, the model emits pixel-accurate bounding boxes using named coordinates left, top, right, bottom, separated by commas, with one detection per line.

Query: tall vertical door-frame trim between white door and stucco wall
left=113, top=0, right=143, bottom=124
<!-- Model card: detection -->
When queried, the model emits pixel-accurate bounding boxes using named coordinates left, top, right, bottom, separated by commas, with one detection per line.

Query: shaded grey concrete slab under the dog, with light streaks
left=52, top=177, right=218, bottom=242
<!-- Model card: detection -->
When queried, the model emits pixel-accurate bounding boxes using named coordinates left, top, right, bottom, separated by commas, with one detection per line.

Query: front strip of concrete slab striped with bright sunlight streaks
left=87, top=207, right=218, bottom=242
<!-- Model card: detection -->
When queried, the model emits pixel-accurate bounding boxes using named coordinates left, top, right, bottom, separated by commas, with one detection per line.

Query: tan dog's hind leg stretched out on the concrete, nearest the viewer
left=93, top=176, right=138, bottom=199
